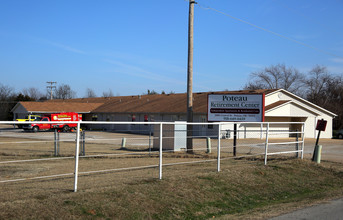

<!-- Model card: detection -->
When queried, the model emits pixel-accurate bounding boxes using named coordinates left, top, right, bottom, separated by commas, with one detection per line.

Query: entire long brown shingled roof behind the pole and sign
left=14, top=89, right=277, bottom=114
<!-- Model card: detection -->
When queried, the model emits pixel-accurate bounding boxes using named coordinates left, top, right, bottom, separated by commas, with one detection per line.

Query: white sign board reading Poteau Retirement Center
left=207, top=94, right=264, bottom=122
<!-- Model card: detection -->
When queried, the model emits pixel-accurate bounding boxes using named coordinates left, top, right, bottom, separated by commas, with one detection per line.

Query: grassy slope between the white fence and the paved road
left=0, top=160, right=343, bottom=219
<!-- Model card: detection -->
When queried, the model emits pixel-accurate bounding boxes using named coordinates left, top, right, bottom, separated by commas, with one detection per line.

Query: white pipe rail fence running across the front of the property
left=0, top=121, right=305, bottom=192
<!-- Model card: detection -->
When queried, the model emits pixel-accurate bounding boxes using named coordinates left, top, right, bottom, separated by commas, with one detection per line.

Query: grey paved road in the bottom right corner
left=270, top=198, right=343, bottom=220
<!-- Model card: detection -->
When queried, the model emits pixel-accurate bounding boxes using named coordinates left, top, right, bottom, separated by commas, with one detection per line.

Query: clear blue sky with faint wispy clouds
left=0, top=0, right=343, bottom=97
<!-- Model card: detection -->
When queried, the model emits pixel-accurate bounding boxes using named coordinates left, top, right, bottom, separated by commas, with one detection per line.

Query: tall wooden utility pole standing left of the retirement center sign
left=187, top=0, right=196, bottom=153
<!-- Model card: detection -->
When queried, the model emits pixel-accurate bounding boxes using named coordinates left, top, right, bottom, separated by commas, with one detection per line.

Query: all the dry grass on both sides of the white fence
left=0, top=127, right=343, bottom=219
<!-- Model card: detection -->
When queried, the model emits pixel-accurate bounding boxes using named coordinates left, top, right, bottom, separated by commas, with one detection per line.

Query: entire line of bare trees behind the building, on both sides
left=0, top=64, right=343, bottom=129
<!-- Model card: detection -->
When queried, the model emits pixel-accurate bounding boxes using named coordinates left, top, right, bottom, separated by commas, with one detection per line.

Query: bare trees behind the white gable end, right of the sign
left=244, top=64, right=343, bottom=129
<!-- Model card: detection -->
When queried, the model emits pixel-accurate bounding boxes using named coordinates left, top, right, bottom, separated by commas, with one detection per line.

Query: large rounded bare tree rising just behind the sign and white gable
left=244, top=64, right=304, bottom=93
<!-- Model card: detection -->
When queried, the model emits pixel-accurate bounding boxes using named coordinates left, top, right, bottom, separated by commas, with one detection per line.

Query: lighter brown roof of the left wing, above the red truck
left=20, top=102, right=103, bottom=113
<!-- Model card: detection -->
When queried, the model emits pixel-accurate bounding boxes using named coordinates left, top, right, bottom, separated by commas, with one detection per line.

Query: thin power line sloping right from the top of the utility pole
left=197, top=3, right=343, bottom=59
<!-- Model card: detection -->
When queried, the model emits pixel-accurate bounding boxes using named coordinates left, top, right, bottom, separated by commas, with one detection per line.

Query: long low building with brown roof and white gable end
left=12, top=89, right=336, bottom=138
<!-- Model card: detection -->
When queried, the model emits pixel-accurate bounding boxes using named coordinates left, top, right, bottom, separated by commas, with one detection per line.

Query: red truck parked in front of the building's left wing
left=23, top=112, right=82, bottom=132
